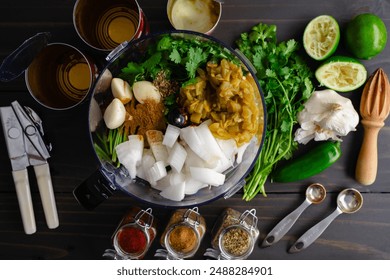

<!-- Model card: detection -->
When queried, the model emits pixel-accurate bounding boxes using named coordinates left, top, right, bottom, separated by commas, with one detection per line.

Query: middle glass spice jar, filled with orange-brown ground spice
left=155, top=207, right=206, bottom=259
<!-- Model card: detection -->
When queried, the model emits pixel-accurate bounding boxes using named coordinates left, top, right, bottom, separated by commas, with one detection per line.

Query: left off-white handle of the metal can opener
left=12, top=169, right=37, bottom=234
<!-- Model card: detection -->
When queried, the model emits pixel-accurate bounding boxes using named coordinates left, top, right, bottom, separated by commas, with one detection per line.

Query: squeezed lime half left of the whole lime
left=303, top=15, right=340, bottom=60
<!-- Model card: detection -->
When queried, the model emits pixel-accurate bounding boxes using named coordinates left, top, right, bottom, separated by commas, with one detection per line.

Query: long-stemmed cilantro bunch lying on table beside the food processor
left=236, top=23, right=314, bottom=201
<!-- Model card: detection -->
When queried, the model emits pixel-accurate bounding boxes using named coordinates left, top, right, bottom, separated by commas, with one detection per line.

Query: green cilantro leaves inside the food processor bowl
left=120, top=34, right=237, bottom=84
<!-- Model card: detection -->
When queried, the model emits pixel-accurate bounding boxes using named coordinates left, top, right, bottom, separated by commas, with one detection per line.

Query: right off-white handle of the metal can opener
left=34, top=163, right=59, bottom=229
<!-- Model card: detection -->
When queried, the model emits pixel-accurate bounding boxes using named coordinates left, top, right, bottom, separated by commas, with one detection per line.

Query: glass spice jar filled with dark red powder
left=103, top=207, right=157, bottom=260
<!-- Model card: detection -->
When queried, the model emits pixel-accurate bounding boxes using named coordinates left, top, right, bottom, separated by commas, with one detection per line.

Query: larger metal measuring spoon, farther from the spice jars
left=288, top=188, right=363, bottom=253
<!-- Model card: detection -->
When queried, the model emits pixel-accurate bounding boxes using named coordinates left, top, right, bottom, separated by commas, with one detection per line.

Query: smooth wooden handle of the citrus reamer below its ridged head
left=355, top=120, right=384, bottom=186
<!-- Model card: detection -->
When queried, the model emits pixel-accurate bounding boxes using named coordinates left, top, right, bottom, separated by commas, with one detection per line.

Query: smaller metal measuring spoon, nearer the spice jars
left=261, top=183, right=326, bottom=247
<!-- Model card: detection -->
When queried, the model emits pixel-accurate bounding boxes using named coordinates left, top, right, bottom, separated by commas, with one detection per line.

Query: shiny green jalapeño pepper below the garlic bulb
left=271, top=141, right=341, bottom=183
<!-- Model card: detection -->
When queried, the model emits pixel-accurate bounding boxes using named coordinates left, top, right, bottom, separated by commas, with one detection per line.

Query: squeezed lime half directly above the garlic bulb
left=315, top=56, right=367, bottom=92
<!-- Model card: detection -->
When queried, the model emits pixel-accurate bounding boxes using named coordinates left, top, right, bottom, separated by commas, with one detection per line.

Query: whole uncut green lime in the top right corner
left=344, top=13, right=387, bottom=59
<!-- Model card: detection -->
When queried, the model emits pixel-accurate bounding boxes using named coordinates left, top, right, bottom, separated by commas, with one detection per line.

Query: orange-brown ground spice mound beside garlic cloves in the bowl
left=124, top=99, right=166, bottom=142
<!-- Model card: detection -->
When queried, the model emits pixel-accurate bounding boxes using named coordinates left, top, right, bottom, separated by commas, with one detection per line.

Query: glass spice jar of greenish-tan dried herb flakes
left=205, top=208, right=260, bottom=260
